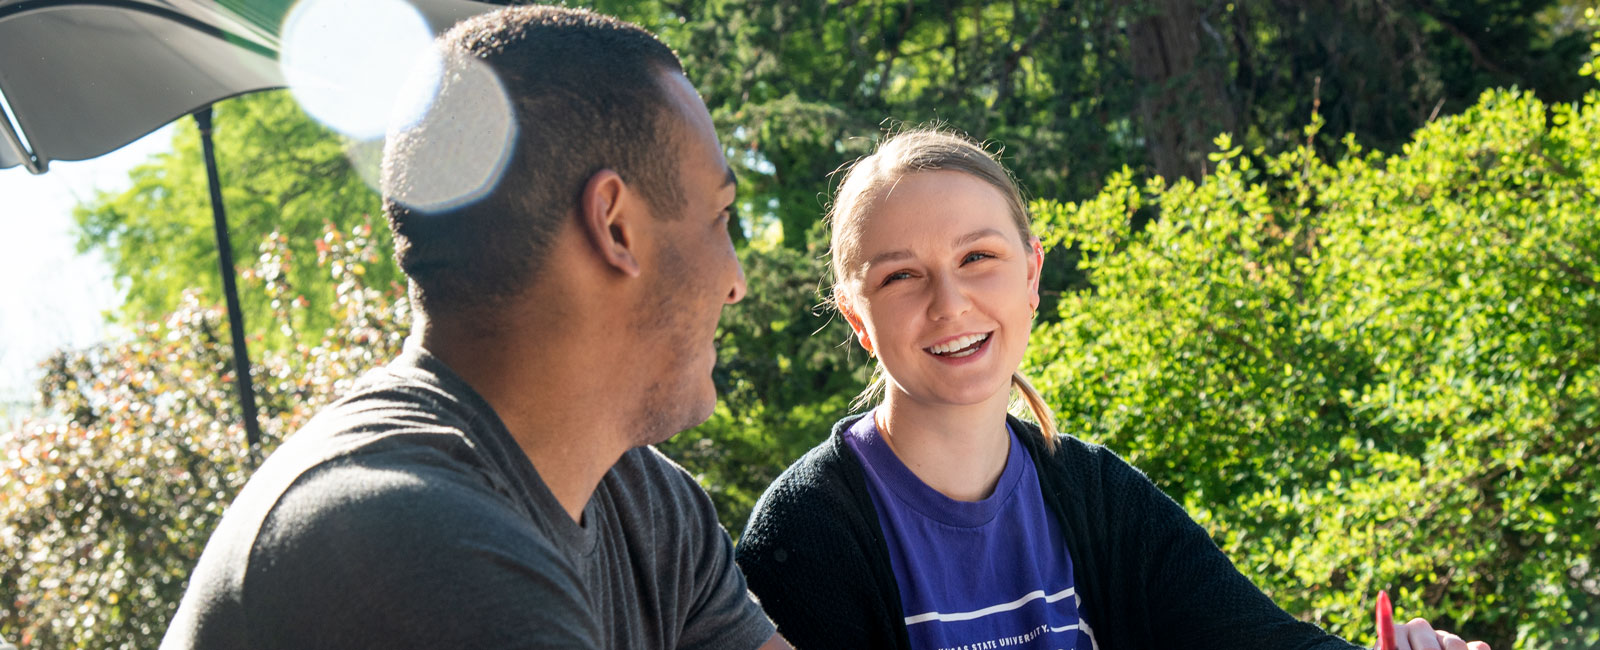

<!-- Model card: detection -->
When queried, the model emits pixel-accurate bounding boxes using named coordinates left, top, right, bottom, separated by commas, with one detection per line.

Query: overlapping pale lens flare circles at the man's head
left=280, top=0, right=515, bottom=211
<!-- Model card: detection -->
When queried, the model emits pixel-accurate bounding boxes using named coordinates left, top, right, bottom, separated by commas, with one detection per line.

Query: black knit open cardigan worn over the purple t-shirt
left=736, top=415, right=1354, bottom=650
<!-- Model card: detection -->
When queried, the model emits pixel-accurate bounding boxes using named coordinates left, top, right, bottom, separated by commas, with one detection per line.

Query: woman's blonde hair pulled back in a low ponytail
left=827, top=126, right=1058, bottom=451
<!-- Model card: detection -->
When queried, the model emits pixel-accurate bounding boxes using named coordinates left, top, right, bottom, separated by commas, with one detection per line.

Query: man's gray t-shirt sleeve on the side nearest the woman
left=659, top=451, right=776, bottom=650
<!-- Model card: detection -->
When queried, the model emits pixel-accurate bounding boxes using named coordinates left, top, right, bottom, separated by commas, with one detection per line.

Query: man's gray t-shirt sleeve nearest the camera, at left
left=243, top=451, right=600, bottom=648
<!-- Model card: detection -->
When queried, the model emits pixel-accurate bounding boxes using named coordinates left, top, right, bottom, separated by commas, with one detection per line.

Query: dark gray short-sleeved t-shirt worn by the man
left=162, top=349, right=773, bottom=648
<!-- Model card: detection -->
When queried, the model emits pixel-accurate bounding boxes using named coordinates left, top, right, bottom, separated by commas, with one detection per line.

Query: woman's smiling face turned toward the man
left=840, top=171, right=1043, bottom=405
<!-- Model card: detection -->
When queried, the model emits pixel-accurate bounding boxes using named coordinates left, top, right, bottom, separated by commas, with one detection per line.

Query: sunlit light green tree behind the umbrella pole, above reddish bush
left=75, top=91, right=400, bottom=346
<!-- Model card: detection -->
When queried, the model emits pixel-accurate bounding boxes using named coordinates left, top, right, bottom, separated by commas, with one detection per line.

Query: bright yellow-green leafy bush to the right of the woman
left=1029, top=80, right=1600, bottom=648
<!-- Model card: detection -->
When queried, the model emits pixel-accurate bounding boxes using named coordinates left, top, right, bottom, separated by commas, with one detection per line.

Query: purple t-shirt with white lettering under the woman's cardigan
left=845, top=413, right=1096, bottom=650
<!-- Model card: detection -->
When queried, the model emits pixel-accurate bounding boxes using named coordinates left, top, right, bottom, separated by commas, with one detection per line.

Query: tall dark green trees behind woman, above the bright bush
left=661, top=0, right=1584, bottom=254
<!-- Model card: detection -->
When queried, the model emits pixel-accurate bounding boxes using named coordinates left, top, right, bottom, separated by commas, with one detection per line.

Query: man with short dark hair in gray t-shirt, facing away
left=162, top=6, right=787, bottom=648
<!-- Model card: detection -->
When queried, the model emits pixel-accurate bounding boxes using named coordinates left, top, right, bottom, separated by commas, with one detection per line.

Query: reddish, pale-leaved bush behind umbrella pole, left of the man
left=0, top=223, right=406, bottom=648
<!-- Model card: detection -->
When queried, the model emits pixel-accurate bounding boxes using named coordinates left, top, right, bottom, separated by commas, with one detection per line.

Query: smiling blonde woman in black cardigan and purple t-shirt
left=738, top=130, right=1486, bottom=650
